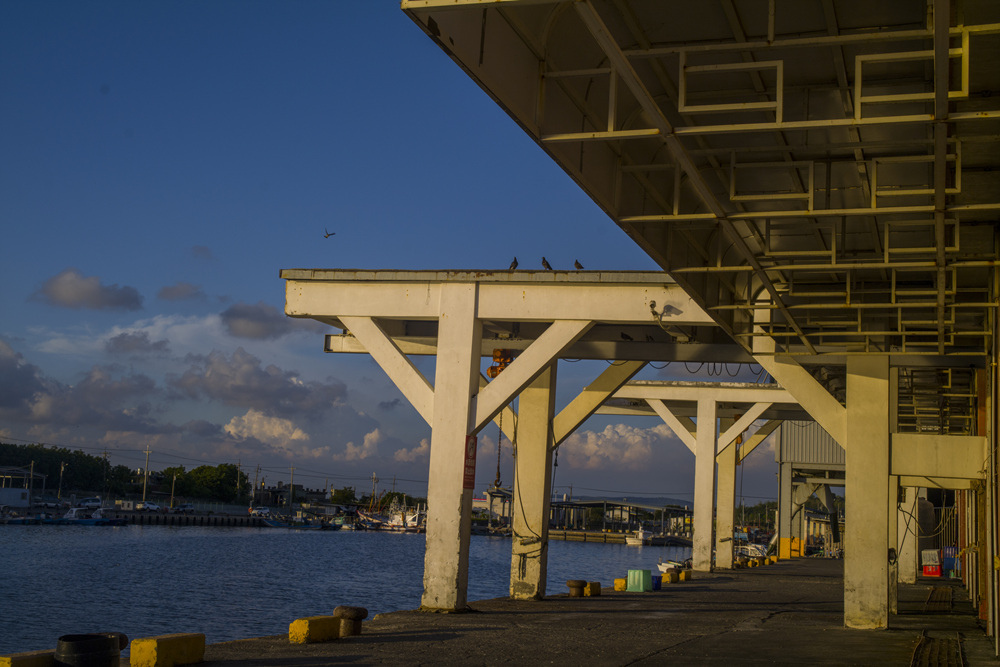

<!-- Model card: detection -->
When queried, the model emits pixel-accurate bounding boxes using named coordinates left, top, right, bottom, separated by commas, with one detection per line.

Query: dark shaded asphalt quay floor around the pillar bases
left=191, top=559, right=1000, bottom=667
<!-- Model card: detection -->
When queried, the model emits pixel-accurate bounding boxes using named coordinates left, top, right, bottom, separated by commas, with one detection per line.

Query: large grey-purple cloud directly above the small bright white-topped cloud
left=168, top=347, right=347, bottom=418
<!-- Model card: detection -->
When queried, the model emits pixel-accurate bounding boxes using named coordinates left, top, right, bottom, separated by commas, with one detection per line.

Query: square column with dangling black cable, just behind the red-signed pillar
left=510, top=363, right=560, bottom=600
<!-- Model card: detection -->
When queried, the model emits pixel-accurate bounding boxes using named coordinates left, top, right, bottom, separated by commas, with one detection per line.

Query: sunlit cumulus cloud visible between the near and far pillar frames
left=559, top=424, right=672, bottom=470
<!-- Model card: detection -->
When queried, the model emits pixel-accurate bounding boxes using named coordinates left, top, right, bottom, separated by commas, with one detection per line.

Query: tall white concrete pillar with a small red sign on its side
left=421, top=283, right=482, bottom=611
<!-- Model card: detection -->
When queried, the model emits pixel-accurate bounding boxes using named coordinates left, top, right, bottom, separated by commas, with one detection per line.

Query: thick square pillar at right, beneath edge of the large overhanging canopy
left=844, top=355, right=890, bottom=629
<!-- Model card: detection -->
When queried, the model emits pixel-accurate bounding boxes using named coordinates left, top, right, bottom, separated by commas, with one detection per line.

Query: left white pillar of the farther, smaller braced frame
left=691, top=398, right=717, bottom=572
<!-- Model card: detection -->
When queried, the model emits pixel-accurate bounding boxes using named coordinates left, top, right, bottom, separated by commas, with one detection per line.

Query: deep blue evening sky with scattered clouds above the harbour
left=0, top=0, right=777, bottom=504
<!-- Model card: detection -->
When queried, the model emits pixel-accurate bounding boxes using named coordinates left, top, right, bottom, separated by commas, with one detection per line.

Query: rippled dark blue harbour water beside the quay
left=0, top=526, right=691, bottom=654
